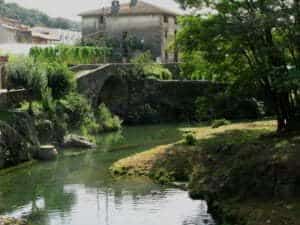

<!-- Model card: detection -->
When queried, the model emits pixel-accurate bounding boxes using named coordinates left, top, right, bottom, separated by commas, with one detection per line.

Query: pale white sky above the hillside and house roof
left=5, top=0, right=180, bottom=20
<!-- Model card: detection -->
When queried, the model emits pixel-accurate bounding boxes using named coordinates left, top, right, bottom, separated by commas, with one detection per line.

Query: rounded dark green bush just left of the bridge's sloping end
left=47, top=63, right=75, bottom=99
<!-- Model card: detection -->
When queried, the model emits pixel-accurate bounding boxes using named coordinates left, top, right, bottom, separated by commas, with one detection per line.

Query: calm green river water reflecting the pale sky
left=0, top=125, right=214, bottom=225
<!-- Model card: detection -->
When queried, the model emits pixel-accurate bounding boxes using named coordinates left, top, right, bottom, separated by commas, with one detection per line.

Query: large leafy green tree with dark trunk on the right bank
left=177, top=0, right=300, bottom=132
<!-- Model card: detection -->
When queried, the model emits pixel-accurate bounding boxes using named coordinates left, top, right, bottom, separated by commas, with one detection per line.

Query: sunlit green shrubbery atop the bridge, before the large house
left=131, top=51, right=172, bottom=80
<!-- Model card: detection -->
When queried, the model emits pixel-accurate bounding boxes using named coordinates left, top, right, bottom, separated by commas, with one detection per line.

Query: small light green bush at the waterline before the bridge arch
left=96, top=104, right=122, bottom=132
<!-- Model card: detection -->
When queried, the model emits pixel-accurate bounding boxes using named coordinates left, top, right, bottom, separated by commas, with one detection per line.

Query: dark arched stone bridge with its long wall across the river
left=77, top=64, right=222, bottom=123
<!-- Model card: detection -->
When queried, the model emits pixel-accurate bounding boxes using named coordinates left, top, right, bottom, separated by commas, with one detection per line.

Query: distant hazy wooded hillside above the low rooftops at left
left=0, top=1, right=80, bottom=30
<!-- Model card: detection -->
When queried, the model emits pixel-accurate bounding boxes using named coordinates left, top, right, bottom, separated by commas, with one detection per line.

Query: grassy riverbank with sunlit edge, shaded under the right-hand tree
left=111, top=121, right=300, bottom=225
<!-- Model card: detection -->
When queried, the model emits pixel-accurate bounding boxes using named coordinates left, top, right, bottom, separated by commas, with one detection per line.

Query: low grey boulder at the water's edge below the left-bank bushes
left=62, top=134, right=96, bottom=148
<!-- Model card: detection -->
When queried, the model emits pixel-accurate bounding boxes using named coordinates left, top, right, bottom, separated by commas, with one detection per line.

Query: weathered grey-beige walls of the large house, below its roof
left=82, top=15, right=178, bottom=62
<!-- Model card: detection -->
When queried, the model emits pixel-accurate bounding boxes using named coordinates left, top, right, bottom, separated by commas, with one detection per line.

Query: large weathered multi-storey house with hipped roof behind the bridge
left=80, top=0, right=178, bottom=62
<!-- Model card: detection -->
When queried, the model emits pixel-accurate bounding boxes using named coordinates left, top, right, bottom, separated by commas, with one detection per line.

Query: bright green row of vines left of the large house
left=30, top=45, right=111, bottom=65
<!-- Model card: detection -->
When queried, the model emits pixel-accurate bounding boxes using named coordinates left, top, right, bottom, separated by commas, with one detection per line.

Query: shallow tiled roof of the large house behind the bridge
left=79, top=0, right=179, bottom=17
